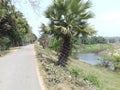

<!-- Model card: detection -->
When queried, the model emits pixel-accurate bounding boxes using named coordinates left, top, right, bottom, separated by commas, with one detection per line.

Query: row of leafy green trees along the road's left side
left=0, top=0, right=37, bottom=50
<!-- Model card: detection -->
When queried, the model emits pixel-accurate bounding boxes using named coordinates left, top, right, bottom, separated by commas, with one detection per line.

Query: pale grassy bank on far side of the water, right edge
left=99, top=43, right=120, bottom=71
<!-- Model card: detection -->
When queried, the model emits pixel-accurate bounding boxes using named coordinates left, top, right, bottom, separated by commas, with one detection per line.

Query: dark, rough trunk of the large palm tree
left=58, top=35, right=71, bottom=67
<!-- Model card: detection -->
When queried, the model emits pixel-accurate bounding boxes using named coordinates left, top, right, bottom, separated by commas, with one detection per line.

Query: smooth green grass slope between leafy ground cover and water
left=68, top=60, right=120, bottom=90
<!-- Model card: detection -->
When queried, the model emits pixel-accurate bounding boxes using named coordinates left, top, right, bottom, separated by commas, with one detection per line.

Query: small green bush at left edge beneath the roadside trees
left=0, top=37, right=10, bottom=51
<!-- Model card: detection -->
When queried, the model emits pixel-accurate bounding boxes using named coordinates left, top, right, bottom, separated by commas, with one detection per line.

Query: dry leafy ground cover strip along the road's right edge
left=35, top=45, right=100, bottom=90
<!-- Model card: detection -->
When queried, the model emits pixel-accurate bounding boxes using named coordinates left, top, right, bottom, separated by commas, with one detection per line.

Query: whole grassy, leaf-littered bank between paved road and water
left=35, top=45, right=120, bottom=90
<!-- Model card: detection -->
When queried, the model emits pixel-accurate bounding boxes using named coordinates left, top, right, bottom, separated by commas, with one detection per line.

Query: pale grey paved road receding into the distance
left=0, top=45, right=40, bottom=90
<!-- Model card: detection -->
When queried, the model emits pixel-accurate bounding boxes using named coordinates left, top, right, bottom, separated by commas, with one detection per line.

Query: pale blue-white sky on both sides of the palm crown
left=14, top=0, right=120, bottom=37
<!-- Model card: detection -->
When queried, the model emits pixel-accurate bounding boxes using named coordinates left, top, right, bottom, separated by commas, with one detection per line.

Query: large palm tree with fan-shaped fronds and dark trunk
left=45, top=0, right=95, bottom=66
